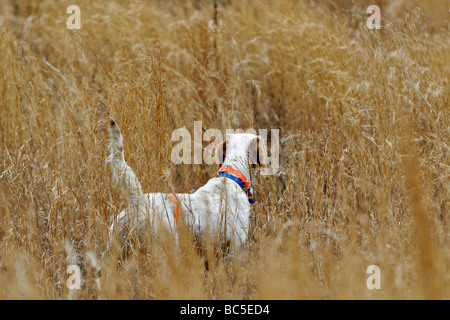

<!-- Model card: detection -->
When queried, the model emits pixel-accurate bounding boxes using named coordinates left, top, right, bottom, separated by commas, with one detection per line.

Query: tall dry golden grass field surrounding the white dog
left=0, top=0, right=450, bottom=299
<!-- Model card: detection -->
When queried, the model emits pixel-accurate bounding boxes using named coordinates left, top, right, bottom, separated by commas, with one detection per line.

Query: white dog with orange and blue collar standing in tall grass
left=107, top=120, right=266, bottom=254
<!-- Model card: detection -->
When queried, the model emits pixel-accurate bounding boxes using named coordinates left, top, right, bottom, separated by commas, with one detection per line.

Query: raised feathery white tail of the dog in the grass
left=106, top=119, right=143, bottom=205
